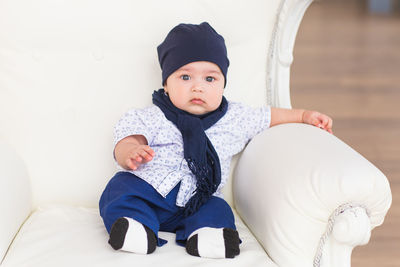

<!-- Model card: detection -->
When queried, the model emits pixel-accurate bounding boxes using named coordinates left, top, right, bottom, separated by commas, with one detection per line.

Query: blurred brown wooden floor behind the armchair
left=291, top=0, right=400, bottom=267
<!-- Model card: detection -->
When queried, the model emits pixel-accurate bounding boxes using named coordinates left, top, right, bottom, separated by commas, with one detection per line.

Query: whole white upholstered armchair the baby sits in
left=0, top=0, right=391, bottom=267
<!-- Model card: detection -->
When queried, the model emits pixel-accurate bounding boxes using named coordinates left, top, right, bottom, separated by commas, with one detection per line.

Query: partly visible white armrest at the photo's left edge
left=0, top=142, right=32, bottom=262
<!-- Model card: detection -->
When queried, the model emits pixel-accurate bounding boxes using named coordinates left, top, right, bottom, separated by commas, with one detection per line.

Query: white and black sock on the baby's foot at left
left=108, top=217, right=157, bottom=254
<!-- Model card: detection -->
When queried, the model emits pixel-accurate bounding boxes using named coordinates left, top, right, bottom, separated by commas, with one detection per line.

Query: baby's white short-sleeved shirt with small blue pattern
left=114, top=102, right=271, bottom=207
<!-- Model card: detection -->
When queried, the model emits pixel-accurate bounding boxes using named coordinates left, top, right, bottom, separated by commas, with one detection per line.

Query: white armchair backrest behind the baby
left=0, top=0, right=311, bottom=209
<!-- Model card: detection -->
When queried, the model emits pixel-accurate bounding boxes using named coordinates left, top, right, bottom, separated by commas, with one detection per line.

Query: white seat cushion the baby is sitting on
left=2, top=206, right=276, bottom=267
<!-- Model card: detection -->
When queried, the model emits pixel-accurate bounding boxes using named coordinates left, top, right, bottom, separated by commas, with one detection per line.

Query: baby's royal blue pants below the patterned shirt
left=99, top=172, right=236, bottom=246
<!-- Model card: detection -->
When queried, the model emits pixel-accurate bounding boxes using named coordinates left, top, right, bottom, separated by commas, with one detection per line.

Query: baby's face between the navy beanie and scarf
left=164, top=61, right=225, bottom=115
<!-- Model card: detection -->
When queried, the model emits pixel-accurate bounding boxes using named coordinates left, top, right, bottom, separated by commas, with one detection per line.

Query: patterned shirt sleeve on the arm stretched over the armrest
left=234, top=103, right=271, bottom=140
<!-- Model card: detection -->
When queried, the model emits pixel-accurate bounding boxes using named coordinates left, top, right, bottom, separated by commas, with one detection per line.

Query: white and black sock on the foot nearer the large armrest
left=186, top=227, right=240, bottom=259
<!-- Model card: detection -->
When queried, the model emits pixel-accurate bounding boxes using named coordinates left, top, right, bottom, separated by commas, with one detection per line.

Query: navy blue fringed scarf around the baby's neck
left=153, top=89, right=228, bottom=217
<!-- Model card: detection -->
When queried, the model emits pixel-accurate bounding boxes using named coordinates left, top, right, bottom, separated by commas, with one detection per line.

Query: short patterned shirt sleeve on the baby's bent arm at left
left=114, top=108, right=160, bottom=147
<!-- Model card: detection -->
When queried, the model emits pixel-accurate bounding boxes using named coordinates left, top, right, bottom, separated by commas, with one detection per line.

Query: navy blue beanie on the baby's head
left=157, top=22, right=229, bottom=87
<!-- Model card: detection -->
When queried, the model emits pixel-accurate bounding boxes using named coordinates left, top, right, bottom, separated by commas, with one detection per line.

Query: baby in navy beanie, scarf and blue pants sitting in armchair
left=100, top=22, right=332, bottom=258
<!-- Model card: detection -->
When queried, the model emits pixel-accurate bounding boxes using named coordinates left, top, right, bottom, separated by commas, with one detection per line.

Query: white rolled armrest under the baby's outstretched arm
left=233, top=123, right=391, bottom=266
